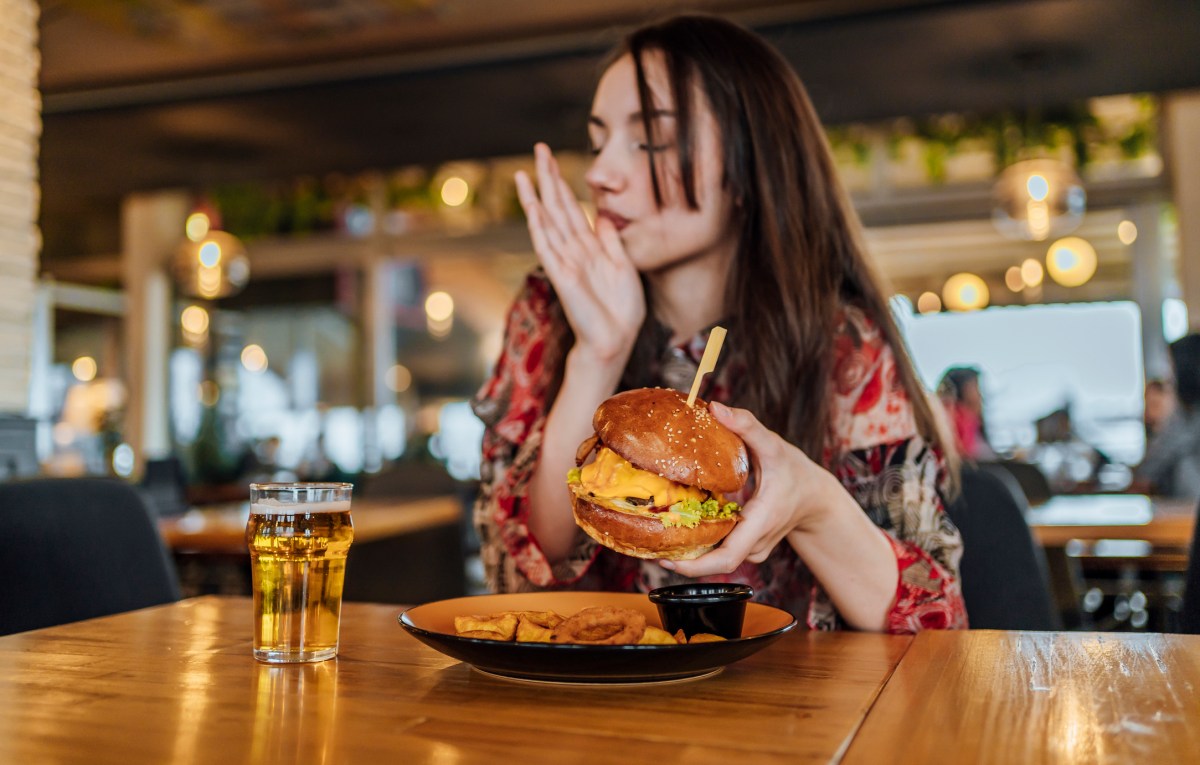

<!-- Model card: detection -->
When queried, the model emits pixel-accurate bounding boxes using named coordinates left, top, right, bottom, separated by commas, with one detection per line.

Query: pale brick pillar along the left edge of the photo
left=0, top=0, right=42, bottom=415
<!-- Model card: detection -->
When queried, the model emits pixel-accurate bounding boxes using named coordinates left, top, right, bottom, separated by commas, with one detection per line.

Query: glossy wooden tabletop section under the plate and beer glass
left=0, top=597, right=911, bottom=765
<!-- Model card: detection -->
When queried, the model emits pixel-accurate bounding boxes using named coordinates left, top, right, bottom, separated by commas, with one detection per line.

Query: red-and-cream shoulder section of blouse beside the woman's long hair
left=830, top=306, right=917, bottom=452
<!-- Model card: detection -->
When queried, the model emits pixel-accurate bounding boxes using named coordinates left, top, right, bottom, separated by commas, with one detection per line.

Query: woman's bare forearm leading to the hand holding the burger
left=787, top=471, right=899, bottom=632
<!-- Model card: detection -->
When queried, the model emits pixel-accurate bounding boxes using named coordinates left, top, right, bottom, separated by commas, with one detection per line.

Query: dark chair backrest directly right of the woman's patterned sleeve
left=947, top=465, right=1062, bottom=630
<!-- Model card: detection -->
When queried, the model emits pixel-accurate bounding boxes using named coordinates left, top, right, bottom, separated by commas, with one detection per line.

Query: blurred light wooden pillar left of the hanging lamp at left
left=121, top=192, right=191, bottom=475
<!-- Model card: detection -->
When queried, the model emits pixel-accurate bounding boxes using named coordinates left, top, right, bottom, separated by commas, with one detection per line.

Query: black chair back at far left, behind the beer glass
left=0, top=478, right=179, bottom=634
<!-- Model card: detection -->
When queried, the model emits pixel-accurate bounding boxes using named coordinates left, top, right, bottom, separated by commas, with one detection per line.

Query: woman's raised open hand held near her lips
left=516, top=144, right=646, bottom=362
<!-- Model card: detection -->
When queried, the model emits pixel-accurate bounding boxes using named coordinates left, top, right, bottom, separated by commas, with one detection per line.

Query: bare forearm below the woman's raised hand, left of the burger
left=527, top=349, right=625, bottom=561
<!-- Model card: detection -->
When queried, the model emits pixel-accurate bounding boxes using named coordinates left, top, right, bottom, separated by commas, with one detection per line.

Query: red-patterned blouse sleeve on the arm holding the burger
left=809, top=305, right=967, bottom=633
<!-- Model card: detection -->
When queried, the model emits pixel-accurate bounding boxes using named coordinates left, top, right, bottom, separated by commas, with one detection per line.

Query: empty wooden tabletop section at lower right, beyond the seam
left=845, top=631, right=1200, bottom=765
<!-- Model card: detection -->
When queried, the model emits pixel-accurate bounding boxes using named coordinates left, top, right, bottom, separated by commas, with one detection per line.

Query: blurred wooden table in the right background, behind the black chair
left=1026, top=494, right=1196, bottom=549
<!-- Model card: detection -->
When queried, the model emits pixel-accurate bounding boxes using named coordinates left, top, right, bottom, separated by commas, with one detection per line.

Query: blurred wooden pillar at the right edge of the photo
left=1163, top=90, right=1200, bottom=332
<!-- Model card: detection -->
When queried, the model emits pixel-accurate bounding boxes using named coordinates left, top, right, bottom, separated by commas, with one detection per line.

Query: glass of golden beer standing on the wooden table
left=246, top=483, right=354, bottom=663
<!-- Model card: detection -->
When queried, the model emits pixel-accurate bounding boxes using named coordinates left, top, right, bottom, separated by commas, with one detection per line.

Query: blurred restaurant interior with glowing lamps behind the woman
left=0, top=0, right=1200, bottom=628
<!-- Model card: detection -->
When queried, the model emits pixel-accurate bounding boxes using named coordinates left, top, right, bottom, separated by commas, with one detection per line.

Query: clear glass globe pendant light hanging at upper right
left=991, top=159, right=1087, bottom=242
